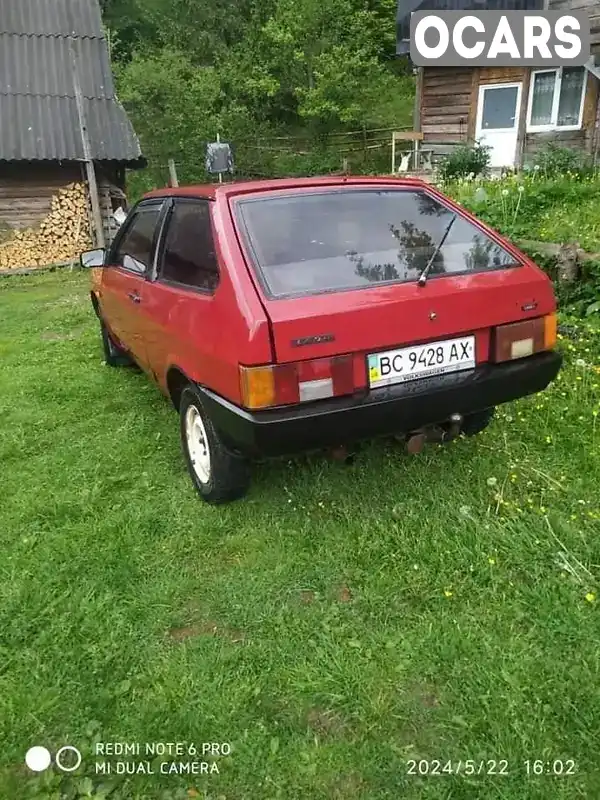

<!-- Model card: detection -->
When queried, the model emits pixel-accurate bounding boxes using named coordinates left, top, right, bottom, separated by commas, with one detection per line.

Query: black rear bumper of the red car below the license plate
left=199, top=352, right=562, bottom=457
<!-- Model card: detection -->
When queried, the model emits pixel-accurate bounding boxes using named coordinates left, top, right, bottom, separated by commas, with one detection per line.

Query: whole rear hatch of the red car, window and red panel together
left=236, top=186, right=555, bottom=372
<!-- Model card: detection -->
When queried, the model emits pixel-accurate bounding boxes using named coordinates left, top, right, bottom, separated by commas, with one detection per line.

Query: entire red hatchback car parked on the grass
left=81, top=177, right=561, bottom=503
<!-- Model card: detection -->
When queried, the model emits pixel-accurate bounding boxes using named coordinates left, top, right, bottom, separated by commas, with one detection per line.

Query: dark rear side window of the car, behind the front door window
left=159, top=200, right=219, bottom=292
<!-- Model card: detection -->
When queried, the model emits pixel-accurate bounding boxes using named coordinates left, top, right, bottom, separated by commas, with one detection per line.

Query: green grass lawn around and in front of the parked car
left=0, top=272, right=600, bottom=800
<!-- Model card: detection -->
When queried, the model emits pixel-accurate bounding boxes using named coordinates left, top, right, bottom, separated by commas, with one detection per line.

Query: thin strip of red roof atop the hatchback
left=144, top=175, right=430, bottom=200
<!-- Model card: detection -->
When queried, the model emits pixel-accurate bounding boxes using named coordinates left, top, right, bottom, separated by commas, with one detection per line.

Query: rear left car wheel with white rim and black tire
left=179, top=386, right=250, bottom=505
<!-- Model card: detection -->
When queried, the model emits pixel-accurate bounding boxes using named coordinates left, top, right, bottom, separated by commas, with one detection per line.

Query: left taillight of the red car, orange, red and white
left=240, top=356, right=354, bottom=410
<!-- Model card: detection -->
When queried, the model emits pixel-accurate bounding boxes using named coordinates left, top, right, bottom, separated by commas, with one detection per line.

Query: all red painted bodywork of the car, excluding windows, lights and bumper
left=95, top=177, right=556, bottom=416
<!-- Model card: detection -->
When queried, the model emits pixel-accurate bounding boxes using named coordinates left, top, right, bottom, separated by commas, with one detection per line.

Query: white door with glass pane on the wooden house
left=475, top=83, right=522, bottom=167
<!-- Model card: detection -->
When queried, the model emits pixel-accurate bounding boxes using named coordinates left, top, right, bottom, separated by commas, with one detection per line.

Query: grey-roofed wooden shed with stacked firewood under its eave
left=0, top=0, right=146, bottom=268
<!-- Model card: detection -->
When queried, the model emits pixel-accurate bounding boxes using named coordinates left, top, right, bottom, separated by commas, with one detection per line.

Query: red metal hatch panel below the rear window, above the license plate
left=266, top=267, right=554, bottom=363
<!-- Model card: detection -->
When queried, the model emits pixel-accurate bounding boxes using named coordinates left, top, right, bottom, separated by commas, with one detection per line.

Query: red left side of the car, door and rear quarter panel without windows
left=97, top=190, right=272, bottom=402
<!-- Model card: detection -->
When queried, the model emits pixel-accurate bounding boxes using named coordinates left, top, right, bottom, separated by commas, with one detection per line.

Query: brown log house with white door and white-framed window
left=397, top=0, right=600, bottom=168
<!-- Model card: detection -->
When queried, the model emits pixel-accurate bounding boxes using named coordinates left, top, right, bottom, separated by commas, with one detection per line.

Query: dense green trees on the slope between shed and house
left=103, top=0, right=413, bottom=190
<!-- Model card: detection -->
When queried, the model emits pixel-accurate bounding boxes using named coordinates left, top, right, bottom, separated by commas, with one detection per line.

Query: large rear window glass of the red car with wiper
left=236, top=189, right=518, bottom=298
